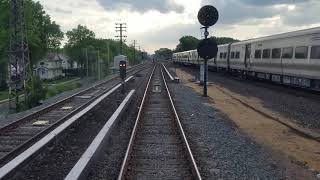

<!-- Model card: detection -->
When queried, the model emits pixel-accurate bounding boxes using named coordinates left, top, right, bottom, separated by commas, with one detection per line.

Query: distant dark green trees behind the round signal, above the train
left=155, top=36, right=239, bottom=59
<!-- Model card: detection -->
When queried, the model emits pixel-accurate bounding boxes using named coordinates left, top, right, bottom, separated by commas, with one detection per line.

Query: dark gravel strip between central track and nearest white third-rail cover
left=87, top=68, right=152, bottom=180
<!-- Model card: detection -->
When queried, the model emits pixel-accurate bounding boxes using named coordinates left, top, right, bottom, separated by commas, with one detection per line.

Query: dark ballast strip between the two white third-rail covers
left=8, top=68, right=151, bottom=179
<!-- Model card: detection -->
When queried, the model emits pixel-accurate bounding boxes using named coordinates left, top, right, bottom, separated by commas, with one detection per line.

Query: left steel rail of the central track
left=118, top=66, right=156, bottom=180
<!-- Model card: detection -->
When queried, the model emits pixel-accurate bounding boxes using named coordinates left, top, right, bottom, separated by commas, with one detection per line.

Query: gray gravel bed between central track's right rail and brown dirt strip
left=169, top=79, right=286, bottom=180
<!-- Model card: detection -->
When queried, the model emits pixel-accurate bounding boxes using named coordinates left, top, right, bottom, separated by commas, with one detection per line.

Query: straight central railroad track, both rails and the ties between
left=118, top=65, right=201, bottom=180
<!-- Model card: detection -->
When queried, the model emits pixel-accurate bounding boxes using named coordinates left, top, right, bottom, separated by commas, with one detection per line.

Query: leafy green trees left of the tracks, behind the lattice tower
left=0, top=0, right=146, bottom=107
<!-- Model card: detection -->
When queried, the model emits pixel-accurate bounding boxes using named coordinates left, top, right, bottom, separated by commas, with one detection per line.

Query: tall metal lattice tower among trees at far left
left=8, top=0, right=32, bottom=112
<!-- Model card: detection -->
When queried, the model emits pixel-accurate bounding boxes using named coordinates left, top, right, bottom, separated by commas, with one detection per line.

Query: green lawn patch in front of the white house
left=46, top=82, right=81, bottom=98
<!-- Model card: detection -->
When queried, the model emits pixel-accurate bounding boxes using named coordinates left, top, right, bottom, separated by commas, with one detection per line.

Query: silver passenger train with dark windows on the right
left=172, top=27, right=320, bottom=90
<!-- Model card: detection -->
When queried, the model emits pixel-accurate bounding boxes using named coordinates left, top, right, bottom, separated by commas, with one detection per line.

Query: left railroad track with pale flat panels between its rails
left=0, top=65, right=149, bottom=167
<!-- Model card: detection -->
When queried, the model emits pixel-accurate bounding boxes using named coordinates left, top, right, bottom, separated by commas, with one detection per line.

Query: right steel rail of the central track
left=161, top=69, right=202, bottom=180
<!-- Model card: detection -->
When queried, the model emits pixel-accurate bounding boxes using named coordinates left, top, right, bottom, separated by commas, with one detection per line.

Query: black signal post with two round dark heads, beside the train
left=197, top=5, right=219, bottom=97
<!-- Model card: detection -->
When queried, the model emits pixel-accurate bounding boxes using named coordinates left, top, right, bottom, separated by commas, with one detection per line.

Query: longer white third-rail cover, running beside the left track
left=0, top=76, right=133, bottom=179
